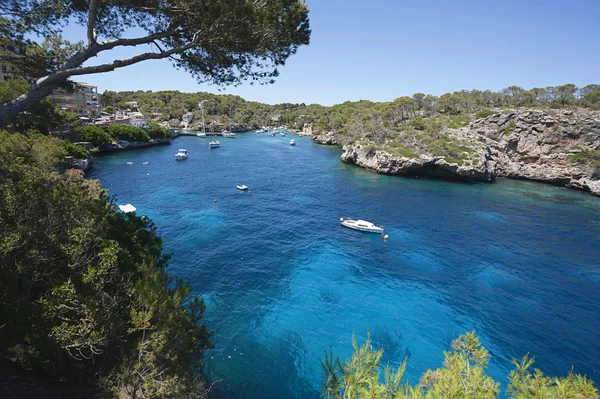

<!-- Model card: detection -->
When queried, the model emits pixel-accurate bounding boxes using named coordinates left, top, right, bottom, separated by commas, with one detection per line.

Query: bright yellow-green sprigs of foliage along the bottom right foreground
left=321, top=332, right=599, bottom=399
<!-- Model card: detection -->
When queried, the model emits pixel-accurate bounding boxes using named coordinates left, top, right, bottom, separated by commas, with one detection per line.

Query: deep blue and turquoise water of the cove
left=91, top=133, right=600, bottom=398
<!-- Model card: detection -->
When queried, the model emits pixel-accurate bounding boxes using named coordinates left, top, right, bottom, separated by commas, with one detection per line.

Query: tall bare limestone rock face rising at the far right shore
left=472, top=110, right=600, bottom=195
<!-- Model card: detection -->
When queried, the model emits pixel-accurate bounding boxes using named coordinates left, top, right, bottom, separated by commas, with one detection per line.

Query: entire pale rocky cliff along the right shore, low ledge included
left=324, top=110, right=600, bottom=195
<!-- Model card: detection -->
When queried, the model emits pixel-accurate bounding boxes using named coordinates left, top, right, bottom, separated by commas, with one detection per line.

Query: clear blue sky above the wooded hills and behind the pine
left=58, top=0, right=600, bottom=105
